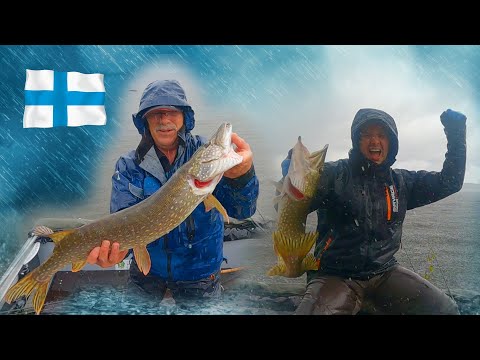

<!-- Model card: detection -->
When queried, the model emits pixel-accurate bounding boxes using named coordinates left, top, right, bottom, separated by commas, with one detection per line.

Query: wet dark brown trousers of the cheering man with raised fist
left=295, top=265, right=459, bottom=315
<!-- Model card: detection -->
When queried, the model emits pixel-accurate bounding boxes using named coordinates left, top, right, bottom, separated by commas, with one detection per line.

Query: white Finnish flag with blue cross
left=23, top=69, right=107, bottom=128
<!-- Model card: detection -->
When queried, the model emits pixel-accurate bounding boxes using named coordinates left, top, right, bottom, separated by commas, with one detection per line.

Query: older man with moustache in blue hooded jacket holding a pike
left=88, top=80, right=259, bottom=301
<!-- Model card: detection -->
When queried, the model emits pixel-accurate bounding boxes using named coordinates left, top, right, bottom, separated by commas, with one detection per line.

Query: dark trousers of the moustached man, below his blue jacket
left=128, top=261, right=222, bottom=304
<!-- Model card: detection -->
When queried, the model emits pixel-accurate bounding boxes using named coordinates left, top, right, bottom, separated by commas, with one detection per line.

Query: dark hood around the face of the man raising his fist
left=351, top=109, right=398, bottom=166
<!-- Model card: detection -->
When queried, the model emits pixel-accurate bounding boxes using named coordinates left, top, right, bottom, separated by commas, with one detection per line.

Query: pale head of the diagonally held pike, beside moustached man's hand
left=188, top=123, right=243, bottom=195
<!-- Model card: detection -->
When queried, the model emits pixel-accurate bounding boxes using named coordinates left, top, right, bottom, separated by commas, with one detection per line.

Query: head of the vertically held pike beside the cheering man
left=284, top=136, right=328, bottom=201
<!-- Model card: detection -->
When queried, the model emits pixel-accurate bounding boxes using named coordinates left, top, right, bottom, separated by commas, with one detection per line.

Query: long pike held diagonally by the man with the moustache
left=5, top=123, right=242, bottom=314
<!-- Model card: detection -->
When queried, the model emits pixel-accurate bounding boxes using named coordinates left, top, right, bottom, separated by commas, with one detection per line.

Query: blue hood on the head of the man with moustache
left=132, top=80, right=195, bottom=135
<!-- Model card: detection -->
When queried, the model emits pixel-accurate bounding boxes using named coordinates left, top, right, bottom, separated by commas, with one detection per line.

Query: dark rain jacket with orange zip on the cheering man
left=309, top=109, right=466, bottom=279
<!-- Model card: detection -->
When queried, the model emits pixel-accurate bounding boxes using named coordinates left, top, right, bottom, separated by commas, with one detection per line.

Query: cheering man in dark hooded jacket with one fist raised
left=282, top=109, right=466, bottom=315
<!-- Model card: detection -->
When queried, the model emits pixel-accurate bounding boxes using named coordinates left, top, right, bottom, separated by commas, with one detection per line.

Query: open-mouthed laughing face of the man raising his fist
left=359, top=123, right=390, bottom=165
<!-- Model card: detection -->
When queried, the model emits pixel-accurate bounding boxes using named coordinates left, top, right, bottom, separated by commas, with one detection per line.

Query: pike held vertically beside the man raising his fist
left=267, top=136, right=328, bottom=278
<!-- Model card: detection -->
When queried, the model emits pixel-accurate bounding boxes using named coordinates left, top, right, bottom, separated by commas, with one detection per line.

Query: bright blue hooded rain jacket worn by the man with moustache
left=110, top=80, right=259, bottom=281
